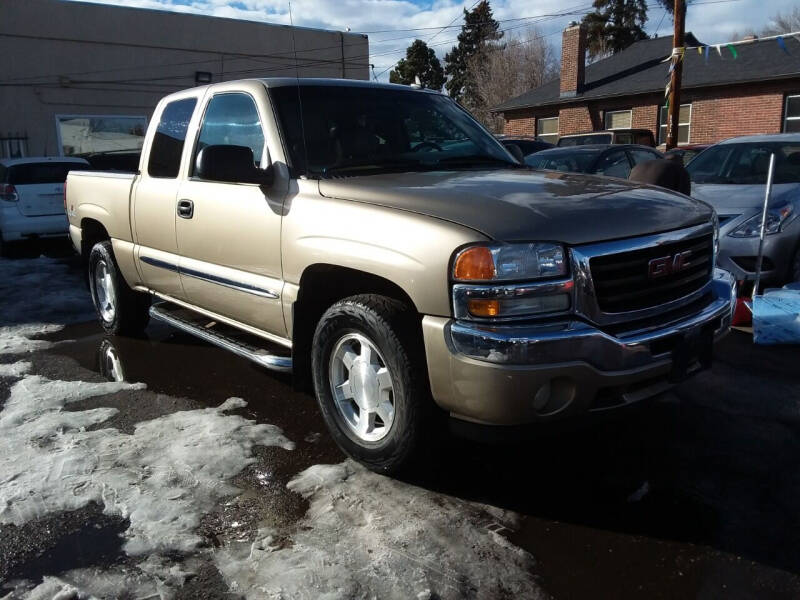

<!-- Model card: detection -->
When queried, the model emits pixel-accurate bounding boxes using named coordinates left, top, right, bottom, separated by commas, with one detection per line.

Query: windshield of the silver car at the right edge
left=686, top=142, right=800, bottom=185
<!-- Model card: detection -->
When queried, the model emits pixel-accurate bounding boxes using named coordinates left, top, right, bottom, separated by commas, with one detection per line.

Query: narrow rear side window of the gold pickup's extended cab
left=147, top=98, right=197, bottom=179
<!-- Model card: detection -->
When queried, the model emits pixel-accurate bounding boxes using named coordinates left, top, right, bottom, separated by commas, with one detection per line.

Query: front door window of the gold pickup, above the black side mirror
left=192, top=93, right=264, bottom=170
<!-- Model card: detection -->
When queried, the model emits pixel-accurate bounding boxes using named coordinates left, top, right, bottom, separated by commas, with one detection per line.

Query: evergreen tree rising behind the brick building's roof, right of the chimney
left=583, top=0, right=647, bottom=59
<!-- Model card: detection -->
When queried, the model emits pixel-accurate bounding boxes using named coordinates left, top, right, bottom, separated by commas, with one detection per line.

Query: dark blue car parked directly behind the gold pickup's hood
left=525, top=144, right=664, bottom=179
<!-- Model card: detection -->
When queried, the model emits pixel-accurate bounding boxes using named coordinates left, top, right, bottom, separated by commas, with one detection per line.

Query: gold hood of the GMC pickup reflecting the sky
left=319, top=169, right=711, bottom=245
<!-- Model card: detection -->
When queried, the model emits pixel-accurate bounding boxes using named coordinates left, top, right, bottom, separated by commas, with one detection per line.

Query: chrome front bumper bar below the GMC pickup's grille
left=449, top=269, right=736, bottom=371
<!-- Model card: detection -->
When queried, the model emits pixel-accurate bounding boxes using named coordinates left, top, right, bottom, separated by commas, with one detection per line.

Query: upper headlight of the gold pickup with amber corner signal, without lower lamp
left=453, top=242, right=567, bottom=282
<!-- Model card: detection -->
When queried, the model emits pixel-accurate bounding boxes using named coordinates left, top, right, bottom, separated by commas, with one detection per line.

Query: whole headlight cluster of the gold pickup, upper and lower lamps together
left=452, top=242, right=574, bottom=321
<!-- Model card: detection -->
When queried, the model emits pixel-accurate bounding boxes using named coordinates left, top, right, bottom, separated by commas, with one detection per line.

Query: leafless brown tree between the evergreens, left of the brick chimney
left=466, top=28, right=556, bottom=132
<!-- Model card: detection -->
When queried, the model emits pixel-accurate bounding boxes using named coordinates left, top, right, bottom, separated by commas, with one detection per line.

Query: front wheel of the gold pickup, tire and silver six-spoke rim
left=311, top=295, right=436, bottom=473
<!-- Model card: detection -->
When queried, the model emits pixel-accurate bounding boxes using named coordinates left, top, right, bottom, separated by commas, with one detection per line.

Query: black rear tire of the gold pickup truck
left=88, top=240, right=150, bottom=336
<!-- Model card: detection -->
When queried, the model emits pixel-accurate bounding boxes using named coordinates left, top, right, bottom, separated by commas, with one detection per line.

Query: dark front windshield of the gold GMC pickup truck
left=270, top=85, right=519, bottom=177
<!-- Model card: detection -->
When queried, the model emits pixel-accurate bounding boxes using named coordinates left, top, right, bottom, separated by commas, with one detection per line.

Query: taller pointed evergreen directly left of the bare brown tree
left=444, top=0, right=503, bottom=106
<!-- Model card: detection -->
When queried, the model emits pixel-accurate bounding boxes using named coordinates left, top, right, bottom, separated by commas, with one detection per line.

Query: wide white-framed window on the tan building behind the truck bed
left=56, top=115, right=147, bottom=156
